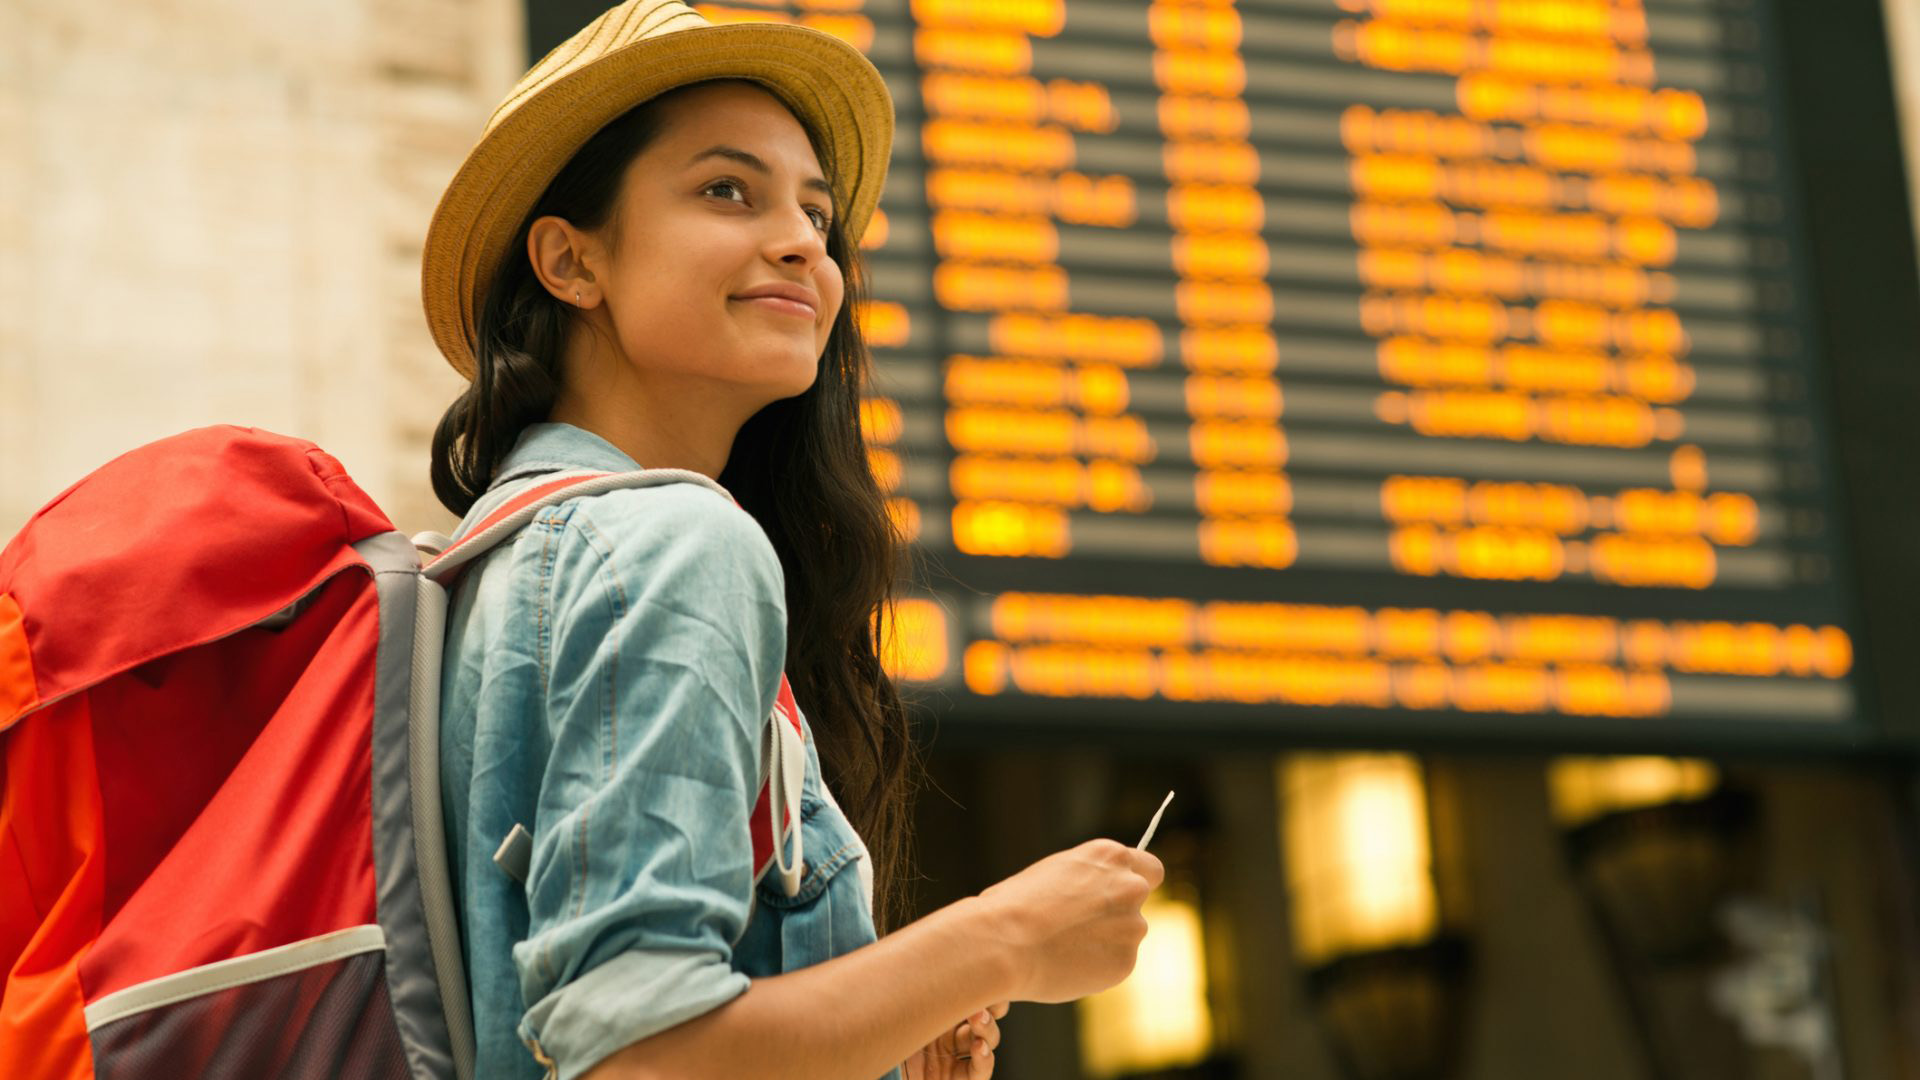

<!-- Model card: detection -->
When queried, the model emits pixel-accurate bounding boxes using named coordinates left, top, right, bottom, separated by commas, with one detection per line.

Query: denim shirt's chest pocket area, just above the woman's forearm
left=755, top=790, right=876, bottom=970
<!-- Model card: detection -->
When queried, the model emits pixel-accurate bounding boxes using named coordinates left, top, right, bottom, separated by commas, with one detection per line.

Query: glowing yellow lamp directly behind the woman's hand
left=1075, top=883, right=1213, bottom=1078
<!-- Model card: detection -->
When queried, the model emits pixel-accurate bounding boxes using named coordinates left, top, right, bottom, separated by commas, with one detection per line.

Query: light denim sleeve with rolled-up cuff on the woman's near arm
left=513, top=484, right=785, bottom=1080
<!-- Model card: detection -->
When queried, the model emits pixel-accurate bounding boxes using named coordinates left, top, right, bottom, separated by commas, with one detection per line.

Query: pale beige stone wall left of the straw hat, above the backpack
left=0, top=0, right=524, bottom=538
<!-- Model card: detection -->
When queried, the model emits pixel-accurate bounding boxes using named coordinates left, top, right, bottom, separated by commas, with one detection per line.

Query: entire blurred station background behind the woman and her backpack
left=0, top=0, right=1920, bottom=1080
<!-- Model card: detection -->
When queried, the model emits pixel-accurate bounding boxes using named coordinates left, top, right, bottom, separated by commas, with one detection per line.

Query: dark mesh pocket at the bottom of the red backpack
left=90, top=951, right=407, bottom=1080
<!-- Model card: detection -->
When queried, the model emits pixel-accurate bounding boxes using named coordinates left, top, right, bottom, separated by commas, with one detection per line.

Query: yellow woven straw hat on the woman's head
left=420, top=0, right=893, bottom=379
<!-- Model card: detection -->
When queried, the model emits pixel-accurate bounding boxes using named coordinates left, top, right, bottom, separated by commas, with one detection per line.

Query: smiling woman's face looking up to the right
left=572, top=83, right=845, bottom=407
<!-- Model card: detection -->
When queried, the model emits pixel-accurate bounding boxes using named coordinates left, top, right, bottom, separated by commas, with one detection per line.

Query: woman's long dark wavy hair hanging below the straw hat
left=432, top=83, right=924, bottom=934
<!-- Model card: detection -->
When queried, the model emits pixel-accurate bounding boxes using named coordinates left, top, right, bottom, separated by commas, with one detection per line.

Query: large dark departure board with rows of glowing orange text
left=664, top=0, right=1857, bottom=738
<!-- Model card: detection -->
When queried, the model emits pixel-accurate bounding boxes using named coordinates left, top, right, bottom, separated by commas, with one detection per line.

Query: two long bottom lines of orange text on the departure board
left=970, top=588, right=1853, bottom=717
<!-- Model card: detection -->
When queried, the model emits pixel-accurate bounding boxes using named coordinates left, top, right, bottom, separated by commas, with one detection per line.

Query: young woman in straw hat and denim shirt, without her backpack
left=424, top=0, right=1162, bottom=1080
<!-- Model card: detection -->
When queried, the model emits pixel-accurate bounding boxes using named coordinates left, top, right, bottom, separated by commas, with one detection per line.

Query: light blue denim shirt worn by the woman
left=440, top=423, right=900, bottom=1080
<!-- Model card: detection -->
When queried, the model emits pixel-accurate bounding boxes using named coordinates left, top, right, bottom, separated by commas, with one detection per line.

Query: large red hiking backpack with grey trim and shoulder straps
left=0, top=427, right=804, bottom=1080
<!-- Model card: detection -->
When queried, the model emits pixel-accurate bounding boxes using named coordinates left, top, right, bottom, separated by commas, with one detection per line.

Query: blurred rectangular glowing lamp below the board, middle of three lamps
left=1277, top=753, right=1440, bottom=965
